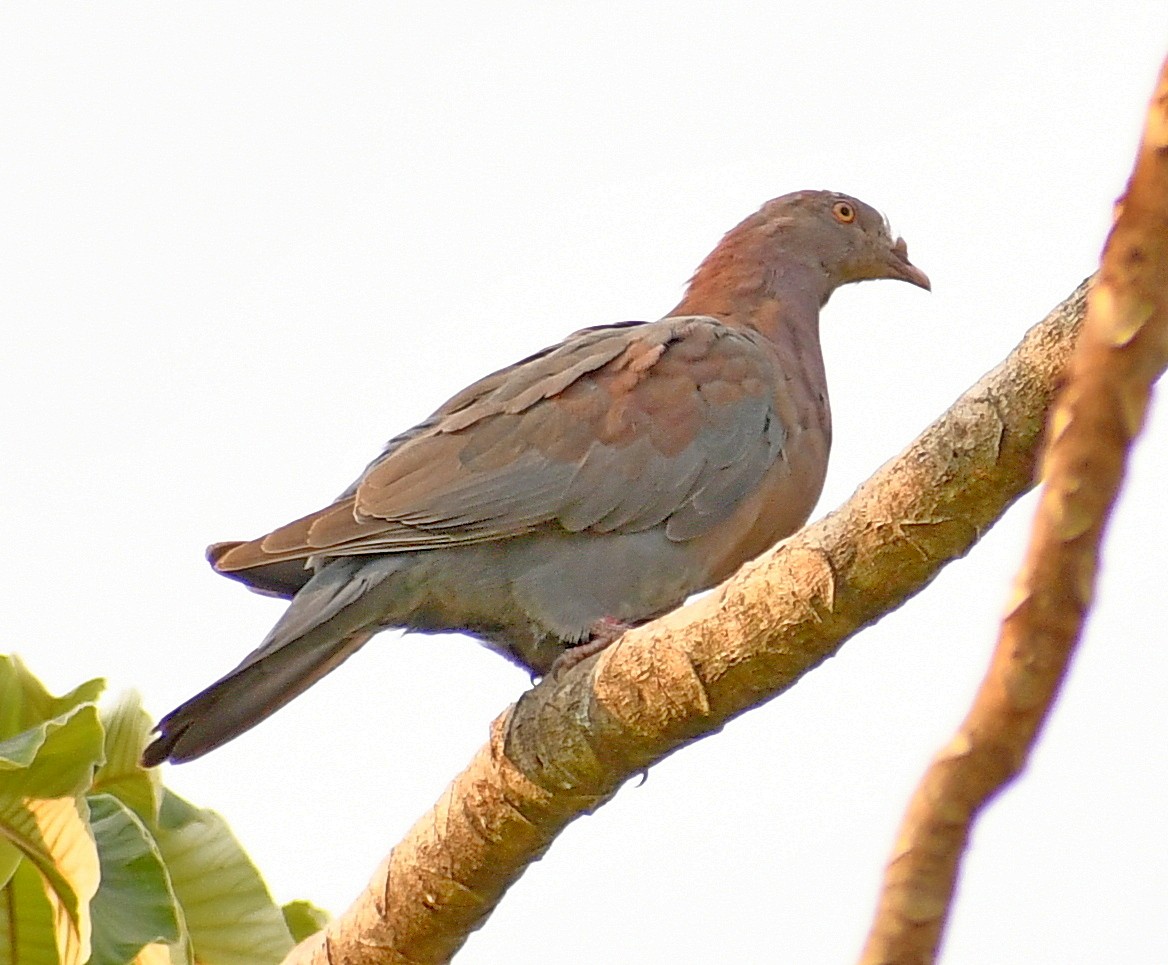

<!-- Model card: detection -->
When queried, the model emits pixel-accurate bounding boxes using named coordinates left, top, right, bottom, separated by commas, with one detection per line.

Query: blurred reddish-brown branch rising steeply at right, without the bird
left=861, top=54, right=1168, bottom=965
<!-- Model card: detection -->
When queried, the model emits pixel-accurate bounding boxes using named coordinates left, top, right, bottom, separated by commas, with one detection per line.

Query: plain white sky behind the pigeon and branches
left=0, top=7, right=1168, bottom=965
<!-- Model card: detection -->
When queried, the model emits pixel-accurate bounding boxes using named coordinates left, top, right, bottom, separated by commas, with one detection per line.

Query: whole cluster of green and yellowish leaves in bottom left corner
left=0, top=655, right=325, bottom=965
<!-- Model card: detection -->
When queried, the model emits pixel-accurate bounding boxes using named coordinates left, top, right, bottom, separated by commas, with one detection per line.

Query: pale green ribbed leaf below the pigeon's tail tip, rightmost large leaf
left=155, top=790, right=293, bottom=965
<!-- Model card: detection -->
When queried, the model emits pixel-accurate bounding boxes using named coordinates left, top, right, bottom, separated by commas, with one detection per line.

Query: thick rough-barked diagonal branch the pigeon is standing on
left=287, top=283, right=1087, bottom=964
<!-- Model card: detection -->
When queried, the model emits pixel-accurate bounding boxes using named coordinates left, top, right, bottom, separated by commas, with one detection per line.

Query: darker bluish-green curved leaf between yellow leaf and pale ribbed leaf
left=89, top=794, right=181, bottom=965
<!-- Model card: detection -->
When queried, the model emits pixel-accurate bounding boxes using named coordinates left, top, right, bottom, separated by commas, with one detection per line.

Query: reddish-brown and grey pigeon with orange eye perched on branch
left=142, top=190, right=930, bottom=766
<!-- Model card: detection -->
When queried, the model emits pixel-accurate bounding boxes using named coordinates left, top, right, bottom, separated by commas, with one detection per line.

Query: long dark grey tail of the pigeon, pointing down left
left=142, top=556, right=398, bottom=768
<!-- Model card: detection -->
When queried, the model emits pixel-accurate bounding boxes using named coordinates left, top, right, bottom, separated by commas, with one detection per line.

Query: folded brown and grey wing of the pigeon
left=213, top=317, right=785, bottom=571
